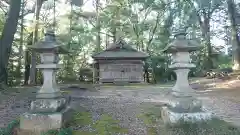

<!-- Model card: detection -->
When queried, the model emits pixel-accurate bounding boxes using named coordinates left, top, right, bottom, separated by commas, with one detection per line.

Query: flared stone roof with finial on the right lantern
left=163, top=32, right=202, bottom=53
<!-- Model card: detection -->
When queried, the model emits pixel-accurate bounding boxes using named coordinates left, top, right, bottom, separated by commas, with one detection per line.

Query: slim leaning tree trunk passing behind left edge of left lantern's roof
left=30, top=0, right=44, bottom=85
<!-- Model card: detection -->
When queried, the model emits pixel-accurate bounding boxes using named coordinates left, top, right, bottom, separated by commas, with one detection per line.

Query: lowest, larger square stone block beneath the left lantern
left=20, top=107, right=73, bottom=132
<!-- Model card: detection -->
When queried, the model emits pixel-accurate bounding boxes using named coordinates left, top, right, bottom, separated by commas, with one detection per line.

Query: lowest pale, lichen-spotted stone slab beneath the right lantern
left=161, top=107, right=213, bottom=126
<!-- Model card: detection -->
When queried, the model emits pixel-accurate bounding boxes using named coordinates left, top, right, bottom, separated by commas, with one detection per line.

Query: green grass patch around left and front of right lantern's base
left=138, top=104, right=240, bottom=135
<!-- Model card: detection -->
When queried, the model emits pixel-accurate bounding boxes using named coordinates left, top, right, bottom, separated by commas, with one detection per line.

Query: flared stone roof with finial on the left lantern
left=28, top=30, right=69, bottom=54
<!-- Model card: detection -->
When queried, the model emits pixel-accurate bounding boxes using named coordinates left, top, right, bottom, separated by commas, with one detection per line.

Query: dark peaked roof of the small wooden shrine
left=92, top=39, right=148, bottom=59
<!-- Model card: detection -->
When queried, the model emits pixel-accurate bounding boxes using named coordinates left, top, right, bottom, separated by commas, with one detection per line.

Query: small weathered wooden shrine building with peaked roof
left=92, top=39, right=148, bottom=83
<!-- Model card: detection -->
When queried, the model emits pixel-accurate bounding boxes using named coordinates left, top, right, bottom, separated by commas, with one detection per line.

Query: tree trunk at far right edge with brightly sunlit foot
left=227, top=0, right=240, bottom=71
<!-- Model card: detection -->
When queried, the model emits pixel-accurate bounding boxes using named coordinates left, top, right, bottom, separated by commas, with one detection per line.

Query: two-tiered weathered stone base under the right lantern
left=161, top=95, right=214, bottom=126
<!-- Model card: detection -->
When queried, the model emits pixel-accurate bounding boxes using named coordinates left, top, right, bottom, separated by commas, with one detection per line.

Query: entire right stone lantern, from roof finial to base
left=161, top=31, right=212, bottom=125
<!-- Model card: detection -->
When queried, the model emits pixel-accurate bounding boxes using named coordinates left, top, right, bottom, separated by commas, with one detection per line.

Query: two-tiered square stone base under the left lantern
left=19, top=98, right=73, bottom=135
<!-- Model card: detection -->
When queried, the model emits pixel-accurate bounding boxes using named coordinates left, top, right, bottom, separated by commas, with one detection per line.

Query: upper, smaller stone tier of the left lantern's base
left=31, top=98, right=67, bottom=113
